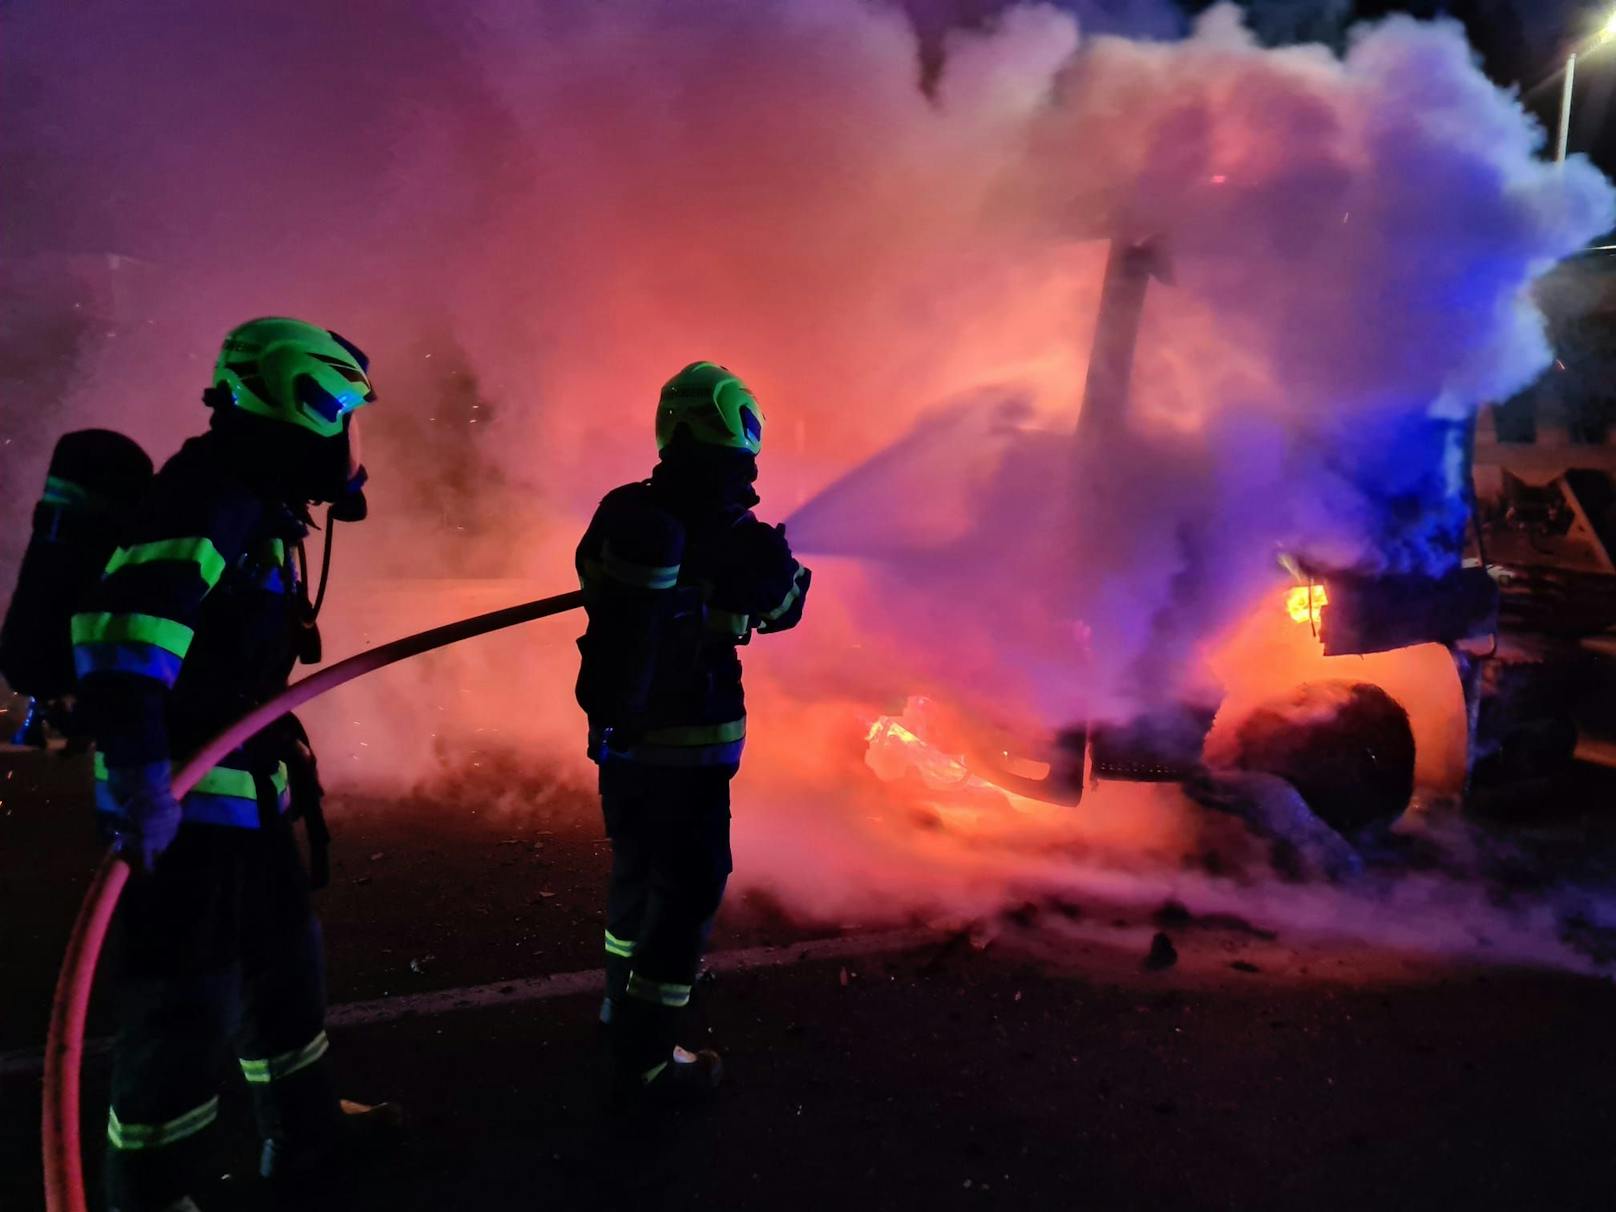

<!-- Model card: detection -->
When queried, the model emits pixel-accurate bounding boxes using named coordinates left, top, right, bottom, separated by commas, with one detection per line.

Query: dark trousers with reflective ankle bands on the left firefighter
left=107, top=818, right=339, bottom=1212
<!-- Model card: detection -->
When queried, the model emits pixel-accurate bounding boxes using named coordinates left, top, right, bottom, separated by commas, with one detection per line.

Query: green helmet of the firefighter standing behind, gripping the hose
left=213, top=315, right=377, bottom=438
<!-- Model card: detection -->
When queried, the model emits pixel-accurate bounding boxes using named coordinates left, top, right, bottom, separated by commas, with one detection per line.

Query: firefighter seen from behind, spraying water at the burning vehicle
left=577, top=362, right=810, bottom=1100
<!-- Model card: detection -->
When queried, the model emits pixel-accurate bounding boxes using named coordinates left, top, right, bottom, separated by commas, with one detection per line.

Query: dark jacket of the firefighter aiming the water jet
left=577, top=461, right=810, bottom=766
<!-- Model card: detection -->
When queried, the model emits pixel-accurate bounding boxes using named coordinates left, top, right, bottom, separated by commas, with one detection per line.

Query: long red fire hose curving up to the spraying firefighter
left=42, top=591, right=583, bottom=1212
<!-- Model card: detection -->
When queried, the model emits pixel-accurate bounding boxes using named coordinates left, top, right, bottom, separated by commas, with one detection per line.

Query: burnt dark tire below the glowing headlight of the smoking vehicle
left=1235, top=682, right=1414, bottom=834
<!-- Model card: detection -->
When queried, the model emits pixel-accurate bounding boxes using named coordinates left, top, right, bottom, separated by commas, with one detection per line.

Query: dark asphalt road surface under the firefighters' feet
left=0, top=753, right=1616, bottom=1212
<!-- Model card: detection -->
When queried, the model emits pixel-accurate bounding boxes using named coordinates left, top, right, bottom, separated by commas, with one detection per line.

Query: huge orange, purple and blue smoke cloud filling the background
left=0, top=0, right=1613, bottom=963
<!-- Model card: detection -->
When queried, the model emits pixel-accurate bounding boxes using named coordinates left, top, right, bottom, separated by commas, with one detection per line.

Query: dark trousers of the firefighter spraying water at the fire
left=600, top=760, right=735, bottom=1073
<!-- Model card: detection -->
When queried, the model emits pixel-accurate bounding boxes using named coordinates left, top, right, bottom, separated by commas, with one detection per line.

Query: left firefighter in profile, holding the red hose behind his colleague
left=73, top=318, right=398, bottom=1212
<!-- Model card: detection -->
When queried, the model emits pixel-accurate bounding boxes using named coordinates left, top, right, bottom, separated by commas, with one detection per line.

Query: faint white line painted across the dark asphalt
left=0, top=929, right=939, bottom=1078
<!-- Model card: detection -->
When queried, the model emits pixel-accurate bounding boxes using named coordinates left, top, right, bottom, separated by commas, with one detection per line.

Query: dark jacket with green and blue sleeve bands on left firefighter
left=73, top=431, right=307, bottom=829
